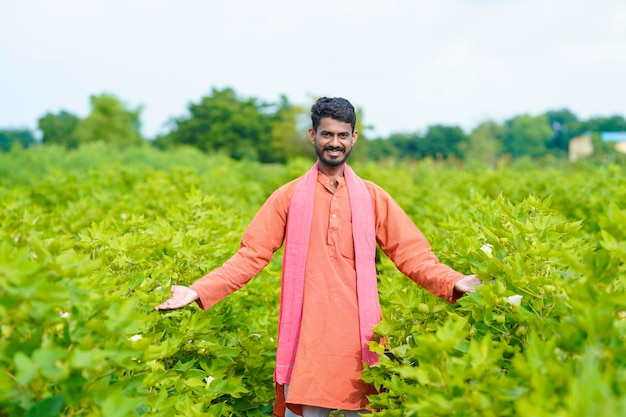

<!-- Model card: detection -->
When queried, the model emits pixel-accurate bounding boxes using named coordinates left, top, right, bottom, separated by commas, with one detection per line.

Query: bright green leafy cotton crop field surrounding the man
left=0, top=144, right=626, bottom=417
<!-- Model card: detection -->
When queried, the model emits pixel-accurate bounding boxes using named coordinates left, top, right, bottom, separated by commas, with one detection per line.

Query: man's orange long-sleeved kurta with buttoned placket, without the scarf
left=191, top=172, right=463, bottom=410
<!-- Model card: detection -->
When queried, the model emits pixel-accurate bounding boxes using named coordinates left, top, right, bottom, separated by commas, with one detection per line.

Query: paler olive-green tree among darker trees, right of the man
left=459, top=120, right=506, bottom=168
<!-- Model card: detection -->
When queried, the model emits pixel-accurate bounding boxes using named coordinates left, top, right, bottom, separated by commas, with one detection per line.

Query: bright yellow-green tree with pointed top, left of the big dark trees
left=74, top=94, right=143, bottom=146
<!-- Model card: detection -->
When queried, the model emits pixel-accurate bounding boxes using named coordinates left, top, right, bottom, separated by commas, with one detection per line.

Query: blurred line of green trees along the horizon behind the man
left=0, top=87, right=626, bottom=165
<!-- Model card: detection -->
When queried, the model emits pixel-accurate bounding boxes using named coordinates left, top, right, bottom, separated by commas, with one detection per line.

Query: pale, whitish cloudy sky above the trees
left=0, top=0, right=626, bottom=137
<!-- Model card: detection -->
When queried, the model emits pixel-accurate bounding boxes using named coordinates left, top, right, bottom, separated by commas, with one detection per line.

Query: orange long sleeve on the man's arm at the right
left=369, top=183, right=464, bottom=303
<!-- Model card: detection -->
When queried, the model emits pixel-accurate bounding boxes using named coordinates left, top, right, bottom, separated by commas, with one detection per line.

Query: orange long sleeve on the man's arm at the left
left=191, top=182, right=293, bottom=310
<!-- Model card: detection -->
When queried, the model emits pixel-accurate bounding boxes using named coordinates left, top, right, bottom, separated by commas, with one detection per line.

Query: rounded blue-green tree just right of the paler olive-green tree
left=504, top=114, right=552, bottom=158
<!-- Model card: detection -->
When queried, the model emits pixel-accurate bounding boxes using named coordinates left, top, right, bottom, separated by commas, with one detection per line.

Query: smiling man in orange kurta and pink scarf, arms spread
left=156, top=97, right=480, bottom=417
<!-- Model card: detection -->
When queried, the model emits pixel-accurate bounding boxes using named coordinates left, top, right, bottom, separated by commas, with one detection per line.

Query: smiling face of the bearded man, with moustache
left=309, top=117, right=359, bottom=167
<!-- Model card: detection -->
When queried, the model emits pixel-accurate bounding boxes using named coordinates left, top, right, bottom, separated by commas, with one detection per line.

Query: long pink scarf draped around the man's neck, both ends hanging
left=274, top=163, right=381, bottom=384
